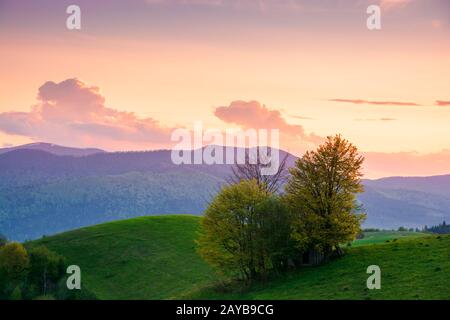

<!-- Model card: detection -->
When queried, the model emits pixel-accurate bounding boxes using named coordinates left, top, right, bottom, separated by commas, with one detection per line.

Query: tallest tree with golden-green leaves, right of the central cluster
left=285, top=135, right=365, bottom=256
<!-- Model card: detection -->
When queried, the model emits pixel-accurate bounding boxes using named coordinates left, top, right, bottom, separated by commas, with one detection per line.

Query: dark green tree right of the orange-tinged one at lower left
left=28, top=246, right=64, bottom=296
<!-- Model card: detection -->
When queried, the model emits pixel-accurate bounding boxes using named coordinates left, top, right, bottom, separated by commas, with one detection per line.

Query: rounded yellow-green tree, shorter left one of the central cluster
left=198, top=179, right=290, bottom=280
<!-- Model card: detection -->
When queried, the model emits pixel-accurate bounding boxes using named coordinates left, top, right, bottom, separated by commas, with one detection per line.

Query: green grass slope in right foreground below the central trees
left=186, top=235, right=450, bottom=299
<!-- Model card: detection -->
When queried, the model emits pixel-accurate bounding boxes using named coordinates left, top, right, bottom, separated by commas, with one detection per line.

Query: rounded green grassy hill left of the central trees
left=29, top=215, right=215, bottom=299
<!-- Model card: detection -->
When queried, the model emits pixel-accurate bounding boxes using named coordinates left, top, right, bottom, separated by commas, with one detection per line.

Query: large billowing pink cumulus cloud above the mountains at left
left=0, top=78, right=172, bottom=149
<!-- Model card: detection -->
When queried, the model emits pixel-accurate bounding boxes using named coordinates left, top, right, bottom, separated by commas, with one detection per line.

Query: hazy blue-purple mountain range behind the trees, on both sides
left=0, top=143, right=450, bottom=240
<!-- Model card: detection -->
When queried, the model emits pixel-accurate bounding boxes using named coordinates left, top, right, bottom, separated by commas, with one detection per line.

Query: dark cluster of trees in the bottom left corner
left=0, top=237, right=65, bottom=300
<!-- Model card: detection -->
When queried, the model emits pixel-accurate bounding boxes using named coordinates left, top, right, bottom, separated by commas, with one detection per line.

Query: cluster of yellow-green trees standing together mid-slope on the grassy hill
left=198, top=135, right=365, bottom=281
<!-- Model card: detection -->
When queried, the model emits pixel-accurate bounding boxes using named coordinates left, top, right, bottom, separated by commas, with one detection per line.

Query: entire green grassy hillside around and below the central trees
left=27, top=215, right=450, bottom=299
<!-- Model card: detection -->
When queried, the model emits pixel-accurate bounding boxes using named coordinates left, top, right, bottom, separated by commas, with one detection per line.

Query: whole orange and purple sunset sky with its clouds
left=0, top=0, right=450, bottom=177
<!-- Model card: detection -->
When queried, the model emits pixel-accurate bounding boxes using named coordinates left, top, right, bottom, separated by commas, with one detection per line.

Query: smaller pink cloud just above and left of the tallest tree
left=214, top=100, right=324, bottom=152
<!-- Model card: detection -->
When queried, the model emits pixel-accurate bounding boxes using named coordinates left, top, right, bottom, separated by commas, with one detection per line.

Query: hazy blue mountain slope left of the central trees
left=0, top=149, right=237, bottom=240
